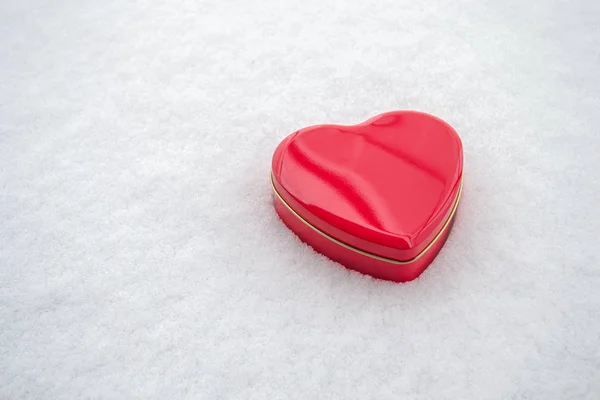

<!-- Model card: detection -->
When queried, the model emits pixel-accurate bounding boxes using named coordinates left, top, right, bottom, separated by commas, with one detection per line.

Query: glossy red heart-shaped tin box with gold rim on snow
left=271, top=111, right=463, bottom=282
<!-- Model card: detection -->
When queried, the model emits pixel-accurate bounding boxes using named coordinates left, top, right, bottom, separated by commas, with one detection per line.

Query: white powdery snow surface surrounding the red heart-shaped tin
left=0, top=0, right=600, bottom=400
